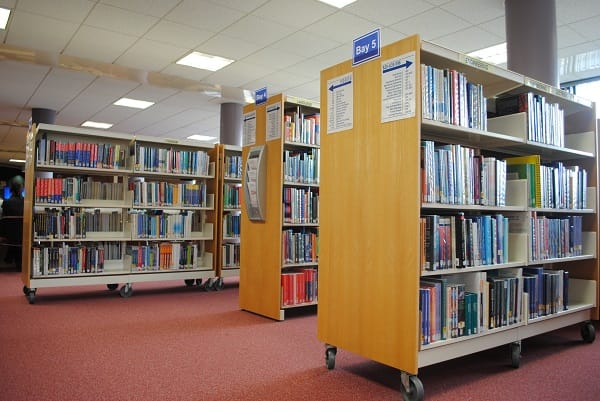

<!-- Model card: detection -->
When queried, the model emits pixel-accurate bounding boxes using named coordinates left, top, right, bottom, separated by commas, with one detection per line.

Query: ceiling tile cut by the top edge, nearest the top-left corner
left=17, top=0, right=96, bottom=24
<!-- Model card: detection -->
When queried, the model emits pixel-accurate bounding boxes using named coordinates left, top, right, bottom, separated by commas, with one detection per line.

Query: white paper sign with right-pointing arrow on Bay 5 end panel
left=381, top=51, right=416, bottom=123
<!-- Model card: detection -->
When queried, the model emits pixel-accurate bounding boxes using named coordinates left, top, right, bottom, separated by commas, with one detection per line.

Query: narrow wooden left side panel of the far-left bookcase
left=21, top=124, right=37, bottom=287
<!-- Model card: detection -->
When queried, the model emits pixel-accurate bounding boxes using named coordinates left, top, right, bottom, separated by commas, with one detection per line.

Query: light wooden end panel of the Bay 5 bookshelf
left=318, top=36, right=421, bottom=373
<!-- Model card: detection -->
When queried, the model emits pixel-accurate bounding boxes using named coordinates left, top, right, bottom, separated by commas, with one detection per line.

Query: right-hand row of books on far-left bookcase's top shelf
left=134, top=143, right=210, bottom=176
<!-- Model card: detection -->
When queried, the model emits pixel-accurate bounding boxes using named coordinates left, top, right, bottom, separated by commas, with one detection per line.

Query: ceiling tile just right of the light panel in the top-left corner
left=6, top=10, right=79, bottom=53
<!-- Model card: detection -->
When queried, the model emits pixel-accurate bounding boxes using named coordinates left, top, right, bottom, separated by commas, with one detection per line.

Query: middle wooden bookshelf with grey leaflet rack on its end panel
left=240, top=94, right=320, bottom=320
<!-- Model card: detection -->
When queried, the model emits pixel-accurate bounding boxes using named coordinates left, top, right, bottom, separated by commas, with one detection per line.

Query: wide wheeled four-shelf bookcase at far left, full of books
left=22, top=124, right=219, bottom=303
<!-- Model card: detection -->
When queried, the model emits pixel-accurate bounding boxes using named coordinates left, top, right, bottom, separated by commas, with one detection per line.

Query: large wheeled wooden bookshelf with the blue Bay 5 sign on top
left=317, top=35, right=599, bottom=400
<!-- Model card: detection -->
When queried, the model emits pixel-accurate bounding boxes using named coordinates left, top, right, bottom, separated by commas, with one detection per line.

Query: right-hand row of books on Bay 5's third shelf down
left=530, top=212, right=583, bottom=260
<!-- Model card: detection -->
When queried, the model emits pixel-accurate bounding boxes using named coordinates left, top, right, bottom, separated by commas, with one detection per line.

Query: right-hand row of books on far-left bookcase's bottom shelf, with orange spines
left=128, top=242, right=203, bottom=271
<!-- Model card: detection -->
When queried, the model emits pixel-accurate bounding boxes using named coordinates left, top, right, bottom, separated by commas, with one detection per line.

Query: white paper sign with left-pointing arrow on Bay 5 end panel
left=327, top=72, right=354, bottom=134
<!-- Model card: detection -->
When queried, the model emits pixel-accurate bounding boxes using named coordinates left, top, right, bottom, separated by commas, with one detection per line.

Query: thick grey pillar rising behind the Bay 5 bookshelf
left=504, top=0, right=560, bottom=87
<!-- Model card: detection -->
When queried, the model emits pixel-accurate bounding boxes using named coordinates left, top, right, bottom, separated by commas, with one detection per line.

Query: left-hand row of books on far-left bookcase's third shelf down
left=33, top=207, right=123, bottom=240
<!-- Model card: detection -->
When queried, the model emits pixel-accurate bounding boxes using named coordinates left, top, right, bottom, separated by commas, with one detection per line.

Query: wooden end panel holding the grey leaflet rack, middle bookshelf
left=240, top=95, right=283, bottom=320
